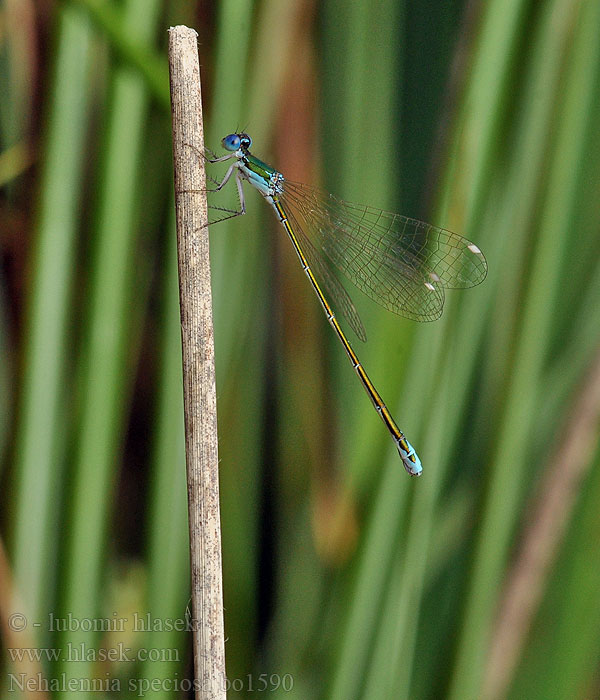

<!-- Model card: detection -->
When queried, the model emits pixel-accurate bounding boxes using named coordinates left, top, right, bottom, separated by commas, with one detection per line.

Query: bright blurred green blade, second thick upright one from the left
left=59, top=0, right=160, bottom=678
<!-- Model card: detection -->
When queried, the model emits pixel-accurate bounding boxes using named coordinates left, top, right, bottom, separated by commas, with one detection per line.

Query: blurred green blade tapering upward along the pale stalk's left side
left=139, top=215, right=190, bottom=700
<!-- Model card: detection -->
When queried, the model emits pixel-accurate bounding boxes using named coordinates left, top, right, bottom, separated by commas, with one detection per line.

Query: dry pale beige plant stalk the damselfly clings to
left=169, top=26, right=225, bottom=700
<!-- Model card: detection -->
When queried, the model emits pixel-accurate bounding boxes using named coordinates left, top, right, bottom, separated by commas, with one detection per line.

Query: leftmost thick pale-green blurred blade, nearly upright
left=13, top=2, right=91, bottom=642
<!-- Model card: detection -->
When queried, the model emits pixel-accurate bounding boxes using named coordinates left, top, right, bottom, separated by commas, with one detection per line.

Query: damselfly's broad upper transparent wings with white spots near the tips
left=279, top=180, right=487, bottom=321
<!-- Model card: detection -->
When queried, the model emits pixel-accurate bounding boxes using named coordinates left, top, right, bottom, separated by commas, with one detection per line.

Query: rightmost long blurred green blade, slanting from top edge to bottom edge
left=451, top=2, right=592, bottom=698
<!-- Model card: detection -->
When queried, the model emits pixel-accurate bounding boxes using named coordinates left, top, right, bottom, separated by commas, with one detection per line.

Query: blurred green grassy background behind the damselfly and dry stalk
left=0, top=0, right=600, bottom=700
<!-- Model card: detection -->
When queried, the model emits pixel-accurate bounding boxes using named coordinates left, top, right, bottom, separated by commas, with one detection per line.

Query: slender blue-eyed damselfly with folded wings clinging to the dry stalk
left=207, top=133, right=487, bottom=476
